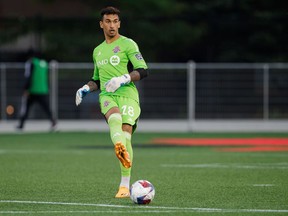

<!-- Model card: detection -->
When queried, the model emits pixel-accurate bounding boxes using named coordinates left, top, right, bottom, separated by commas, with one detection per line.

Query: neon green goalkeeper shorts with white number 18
left=99, top=95, right=141, bottom=131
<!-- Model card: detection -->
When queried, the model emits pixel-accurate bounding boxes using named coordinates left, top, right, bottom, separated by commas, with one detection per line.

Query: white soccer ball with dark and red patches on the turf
left=130, top=180, right=155, bottom=204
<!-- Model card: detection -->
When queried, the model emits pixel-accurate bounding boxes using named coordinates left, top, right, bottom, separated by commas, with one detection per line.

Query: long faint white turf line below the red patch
left=161, top=163, right=288, bottom=169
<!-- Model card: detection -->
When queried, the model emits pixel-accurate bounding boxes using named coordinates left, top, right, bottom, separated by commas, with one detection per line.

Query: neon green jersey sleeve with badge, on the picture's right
left=127, top=39, right=147, bottom=69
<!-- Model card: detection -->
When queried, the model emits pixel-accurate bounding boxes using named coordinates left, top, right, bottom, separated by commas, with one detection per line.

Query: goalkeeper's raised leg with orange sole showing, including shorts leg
left=100, top=96, right=131, bottom=168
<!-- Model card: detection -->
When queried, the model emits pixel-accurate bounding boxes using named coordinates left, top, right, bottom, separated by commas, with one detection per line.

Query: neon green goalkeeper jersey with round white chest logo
left=92, top=35, right=147, bottom=102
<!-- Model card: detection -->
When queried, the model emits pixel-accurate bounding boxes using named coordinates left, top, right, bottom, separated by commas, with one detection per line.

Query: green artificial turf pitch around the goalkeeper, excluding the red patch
left=0, top=132, right=288, bottom=216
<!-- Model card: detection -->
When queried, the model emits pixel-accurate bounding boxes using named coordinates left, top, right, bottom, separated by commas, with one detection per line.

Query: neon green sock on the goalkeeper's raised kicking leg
left=108, top=113, right=126, bottom=147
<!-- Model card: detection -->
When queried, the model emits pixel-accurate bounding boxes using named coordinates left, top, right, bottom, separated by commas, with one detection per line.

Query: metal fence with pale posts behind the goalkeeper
left=0, top=61, right=288, bottom=130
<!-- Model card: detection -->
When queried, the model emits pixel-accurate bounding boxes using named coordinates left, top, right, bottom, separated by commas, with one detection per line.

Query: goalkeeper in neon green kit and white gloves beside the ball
left=75, top=7, right=148, bottom=198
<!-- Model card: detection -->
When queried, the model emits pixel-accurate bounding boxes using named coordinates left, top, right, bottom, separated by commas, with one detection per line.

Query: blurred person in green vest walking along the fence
left=17, top=50, right=56, bottom=130
